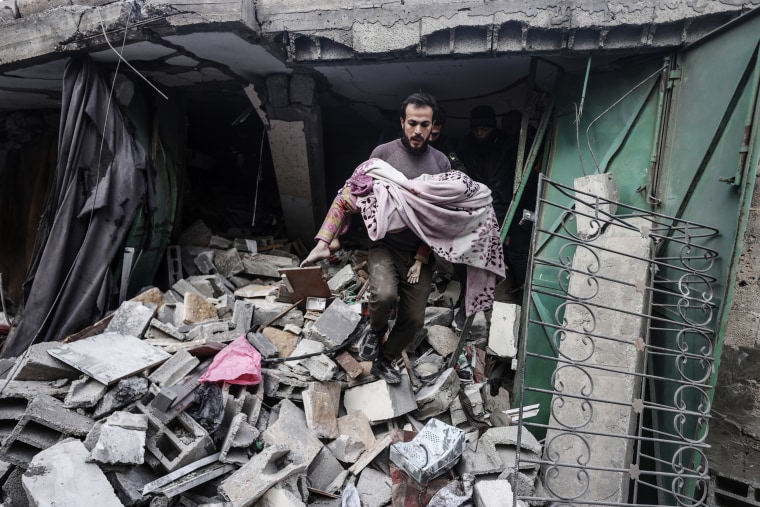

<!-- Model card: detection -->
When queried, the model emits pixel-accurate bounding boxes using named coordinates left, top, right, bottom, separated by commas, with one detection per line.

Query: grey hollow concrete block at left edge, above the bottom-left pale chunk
left=0, top=395, right=94, bottom=468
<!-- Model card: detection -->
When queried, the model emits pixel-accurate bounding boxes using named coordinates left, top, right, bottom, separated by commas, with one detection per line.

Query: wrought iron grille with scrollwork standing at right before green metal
left=513, top=178, right=718, bottom=507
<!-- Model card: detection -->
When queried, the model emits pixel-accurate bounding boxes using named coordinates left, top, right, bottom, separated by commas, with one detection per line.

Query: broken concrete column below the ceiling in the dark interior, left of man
left=245, top=74, right=327, bottom=248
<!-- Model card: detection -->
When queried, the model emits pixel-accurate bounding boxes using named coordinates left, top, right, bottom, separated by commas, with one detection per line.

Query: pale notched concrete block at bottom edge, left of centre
left=219, top=445, right=308, bottom=507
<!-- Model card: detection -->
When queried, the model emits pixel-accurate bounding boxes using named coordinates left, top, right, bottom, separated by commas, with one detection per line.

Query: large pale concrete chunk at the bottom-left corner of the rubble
left=21, top=439, right=123, bottom=507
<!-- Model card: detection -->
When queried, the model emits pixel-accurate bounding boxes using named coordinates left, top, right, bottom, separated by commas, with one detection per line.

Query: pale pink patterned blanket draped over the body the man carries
left=349, top=158, right=505, bottom=315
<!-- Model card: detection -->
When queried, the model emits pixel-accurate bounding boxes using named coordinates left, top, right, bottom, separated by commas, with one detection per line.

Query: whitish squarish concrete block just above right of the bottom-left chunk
left=85, top=412, right=148, bottom=465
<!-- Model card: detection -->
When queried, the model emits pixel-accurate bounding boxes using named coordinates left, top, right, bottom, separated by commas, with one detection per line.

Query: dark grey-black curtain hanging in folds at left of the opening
left=2, top=57, right=153, bottom=357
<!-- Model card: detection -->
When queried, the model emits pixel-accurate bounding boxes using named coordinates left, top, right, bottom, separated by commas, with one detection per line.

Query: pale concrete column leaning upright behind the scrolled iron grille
left=544, top=215, right=652, bottom=506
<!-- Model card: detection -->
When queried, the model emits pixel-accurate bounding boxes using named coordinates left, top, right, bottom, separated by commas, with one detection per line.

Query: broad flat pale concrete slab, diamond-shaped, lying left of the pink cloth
left=48, top=332, right=170, bottom=385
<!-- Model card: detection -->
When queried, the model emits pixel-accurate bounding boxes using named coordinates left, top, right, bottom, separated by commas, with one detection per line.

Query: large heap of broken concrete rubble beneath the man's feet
left=0, top=222, right=542, bottom=507
